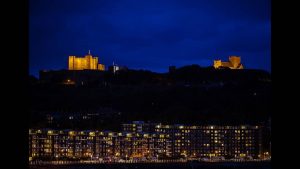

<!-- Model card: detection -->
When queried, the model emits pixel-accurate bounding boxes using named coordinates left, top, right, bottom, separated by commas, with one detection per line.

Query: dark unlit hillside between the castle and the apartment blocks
left=30, top=65, right=271, bottom=129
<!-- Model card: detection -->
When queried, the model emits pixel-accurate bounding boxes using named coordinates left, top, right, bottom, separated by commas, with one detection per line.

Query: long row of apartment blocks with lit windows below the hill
left=29, top=123, right=270, bottom=161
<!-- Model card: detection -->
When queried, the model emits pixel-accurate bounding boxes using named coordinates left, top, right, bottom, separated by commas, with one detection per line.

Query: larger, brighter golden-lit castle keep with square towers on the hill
left=69, top=50, right=105, bottom=71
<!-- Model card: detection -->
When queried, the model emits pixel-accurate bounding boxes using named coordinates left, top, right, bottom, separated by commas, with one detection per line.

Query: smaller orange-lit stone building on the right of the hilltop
left=214, top=56, right=244, bottom=69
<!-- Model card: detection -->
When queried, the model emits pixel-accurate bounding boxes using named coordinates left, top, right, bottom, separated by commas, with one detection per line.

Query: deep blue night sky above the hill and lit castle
left=29, top=0, right=271, bottom=76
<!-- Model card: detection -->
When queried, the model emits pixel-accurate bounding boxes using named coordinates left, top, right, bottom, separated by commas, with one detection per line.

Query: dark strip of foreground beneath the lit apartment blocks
left=29, top=162, right=271, bottom=169
